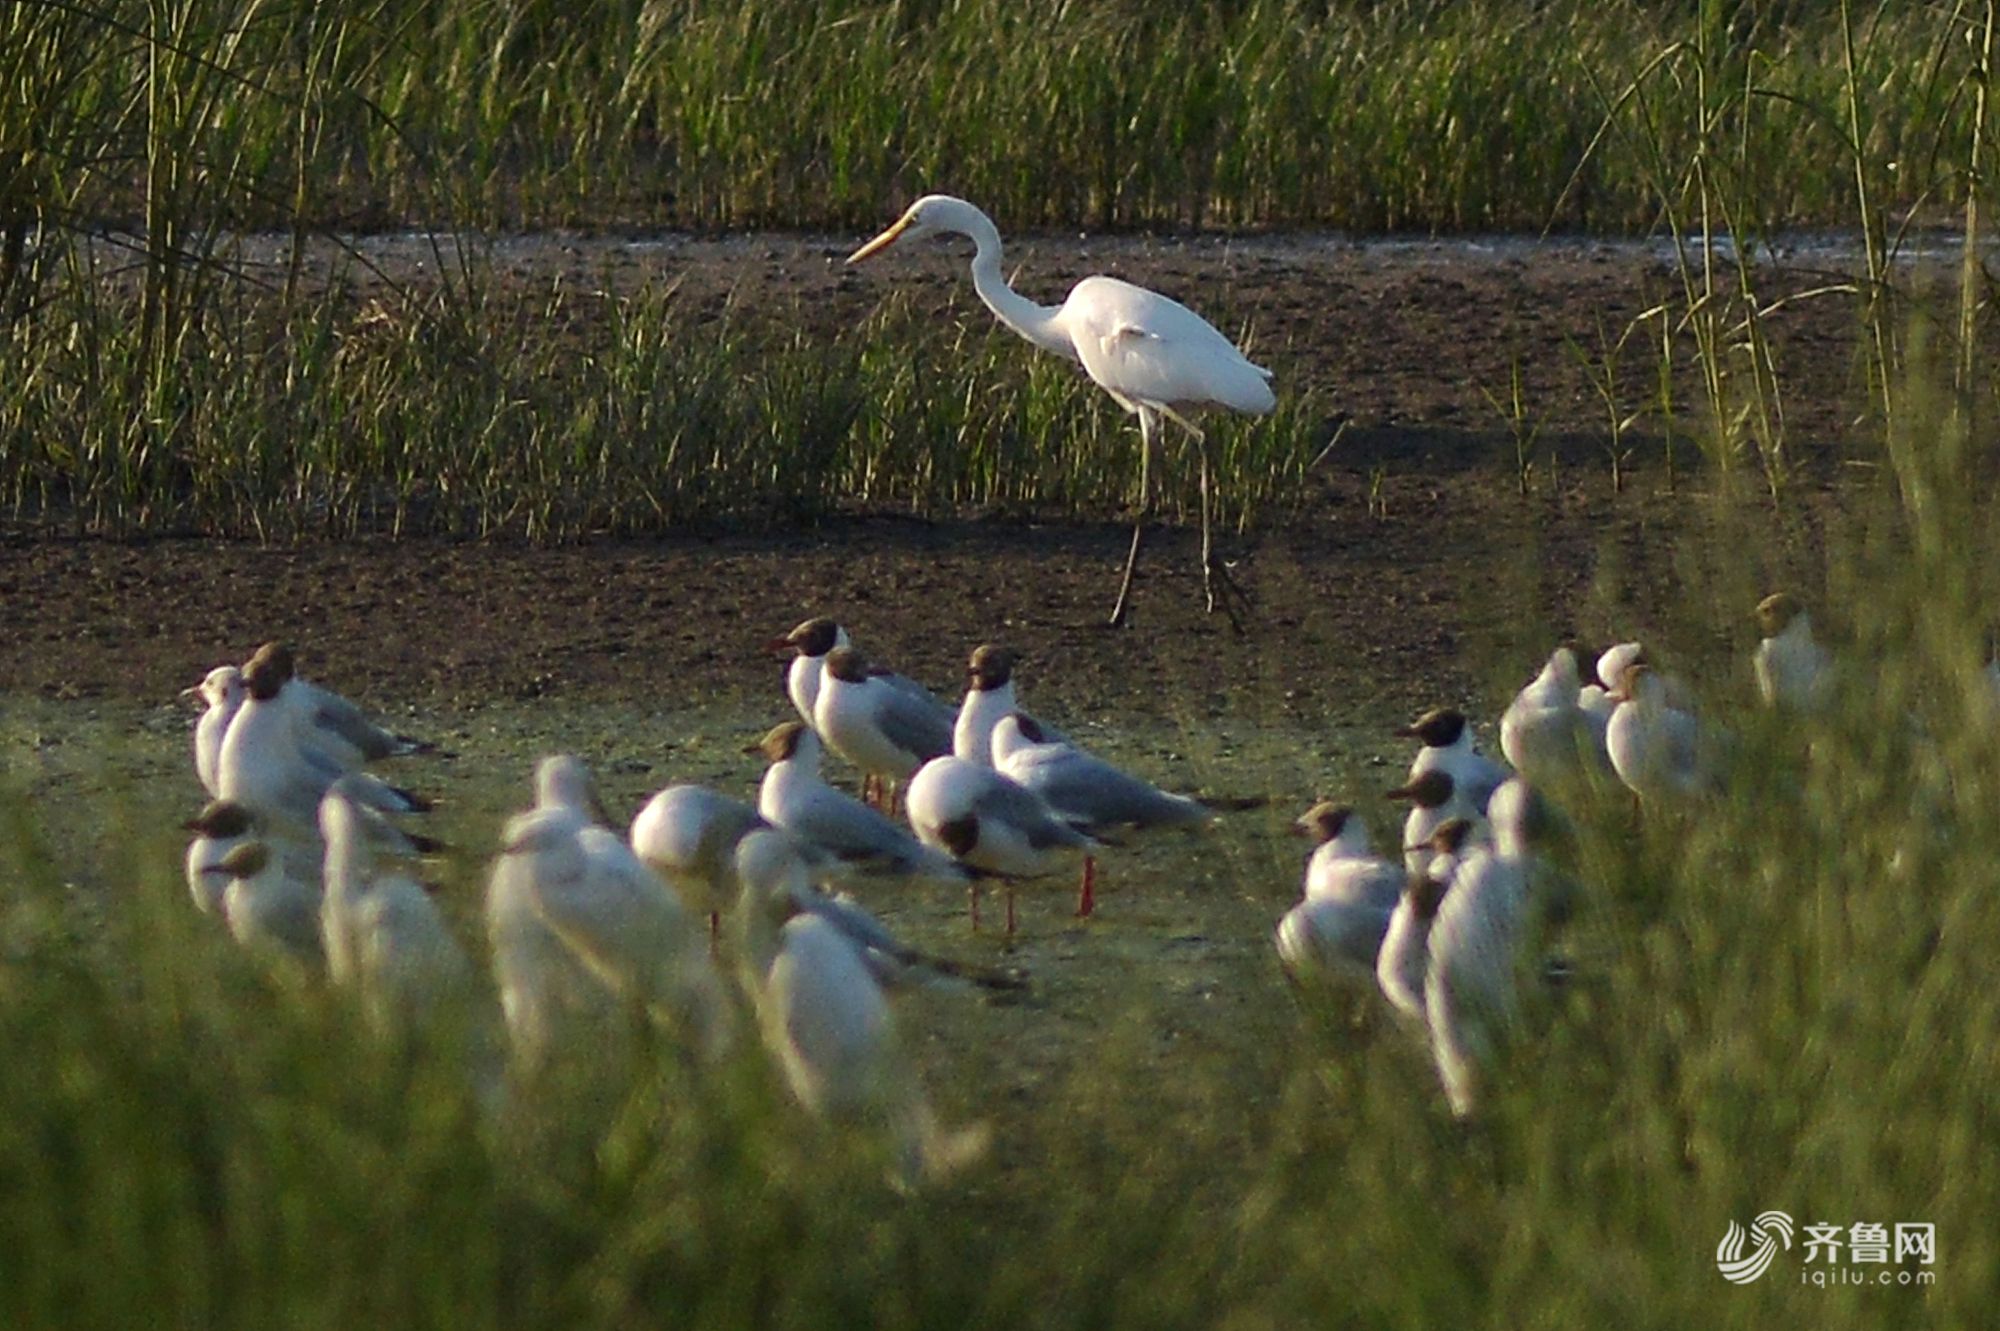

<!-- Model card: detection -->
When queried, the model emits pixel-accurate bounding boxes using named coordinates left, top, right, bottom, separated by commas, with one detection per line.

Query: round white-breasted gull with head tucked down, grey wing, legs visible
left=906, top=755, right=1098, bottom=933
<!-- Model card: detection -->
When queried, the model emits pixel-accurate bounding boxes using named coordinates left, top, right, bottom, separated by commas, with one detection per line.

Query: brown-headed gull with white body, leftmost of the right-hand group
left=1276, top=801, right=1404, bottom=987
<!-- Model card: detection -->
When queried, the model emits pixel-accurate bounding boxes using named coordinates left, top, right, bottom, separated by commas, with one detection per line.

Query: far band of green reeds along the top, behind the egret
left=0, top=0, right=1974, bottom=232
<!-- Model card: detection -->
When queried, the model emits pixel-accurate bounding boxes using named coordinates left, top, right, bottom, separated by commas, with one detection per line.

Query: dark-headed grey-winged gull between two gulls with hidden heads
left=750, top=721, right=968, bottom=887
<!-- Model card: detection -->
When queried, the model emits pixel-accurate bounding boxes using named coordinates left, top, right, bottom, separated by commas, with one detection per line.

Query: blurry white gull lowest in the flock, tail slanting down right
left=736, top=831, right=988, bottom=1187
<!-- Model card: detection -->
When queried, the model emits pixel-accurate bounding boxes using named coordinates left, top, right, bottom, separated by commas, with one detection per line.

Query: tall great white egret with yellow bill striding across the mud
left=848, top=194, right=1278, bottom=628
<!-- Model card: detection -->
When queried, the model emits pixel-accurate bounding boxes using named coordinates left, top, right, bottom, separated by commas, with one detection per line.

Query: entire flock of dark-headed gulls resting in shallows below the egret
left=172, top=594, right=1856, bottom=1183
